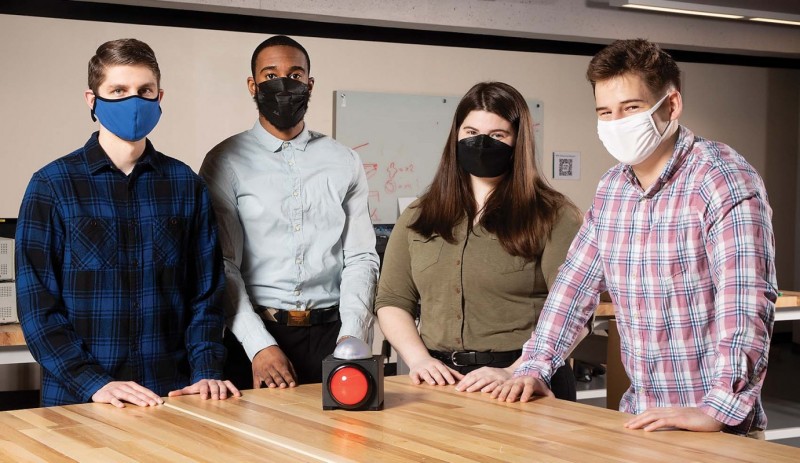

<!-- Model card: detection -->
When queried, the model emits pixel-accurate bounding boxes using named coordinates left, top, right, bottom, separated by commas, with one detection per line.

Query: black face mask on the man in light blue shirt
left=254, top=77, right=310, bottom=130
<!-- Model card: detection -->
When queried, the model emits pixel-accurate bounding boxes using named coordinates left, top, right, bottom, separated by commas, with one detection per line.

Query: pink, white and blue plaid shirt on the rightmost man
left=515, top=127, right=777, bottom=434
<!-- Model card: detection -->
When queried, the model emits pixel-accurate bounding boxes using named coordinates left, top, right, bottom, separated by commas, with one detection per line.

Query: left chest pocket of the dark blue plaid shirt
left=70, top=217, right=118, bottom=270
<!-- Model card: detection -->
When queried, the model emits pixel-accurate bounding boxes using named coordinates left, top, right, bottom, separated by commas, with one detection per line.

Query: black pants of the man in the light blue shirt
left=223, top=321, right=342, bottom=389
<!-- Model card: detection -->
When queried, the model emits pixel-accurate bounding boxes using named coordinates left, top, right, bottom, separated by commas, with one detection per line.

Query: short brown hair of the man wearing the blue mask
left=89, top=39, right=161, bottom=94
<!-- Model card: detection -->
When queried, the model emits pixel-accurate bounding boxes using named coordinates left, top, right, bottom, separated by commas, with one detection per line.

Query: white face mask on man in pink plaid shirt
left=597, top=93, right=678, bottom=166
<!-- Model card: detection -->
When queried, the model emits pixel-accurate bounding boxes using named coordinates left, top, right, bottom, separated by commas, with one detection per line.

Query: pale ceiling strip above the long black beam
left=72, top=0, right=800, bottom=59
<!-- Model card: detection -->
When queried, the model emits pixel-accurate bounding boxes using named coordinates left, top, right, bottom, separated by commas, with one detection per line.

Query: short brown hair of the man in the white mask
left=586, top=39, right=681, bottom=94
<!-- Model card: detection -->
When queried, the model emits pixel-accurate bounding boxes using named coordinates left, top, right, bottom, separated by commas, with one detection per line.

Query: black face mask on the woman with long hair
left=456, top=135, right=514, bottom=178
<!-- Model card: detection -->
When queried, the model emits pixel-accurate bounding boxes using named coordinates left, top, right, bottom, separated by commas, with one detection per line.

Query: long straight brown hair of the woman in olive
left=410, top=82, right=579, bottom=260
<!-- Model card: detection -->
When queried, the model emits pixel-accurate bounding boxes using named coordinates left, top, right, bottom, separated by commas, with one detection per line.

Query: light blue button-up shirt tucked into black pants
left=200, top=122, right=378, bottom=360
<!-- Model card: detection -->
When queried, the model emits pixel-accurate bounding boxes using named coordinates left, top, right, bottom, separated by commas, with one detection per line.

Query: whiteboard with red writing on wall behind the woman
left=333, top=90, right=544, bottom=224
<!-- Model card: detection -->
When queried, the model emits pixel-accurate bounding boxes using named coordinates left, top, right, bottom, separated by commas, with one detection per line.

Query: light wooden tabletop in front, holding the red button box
left=0, top=376, right=800, bottom=463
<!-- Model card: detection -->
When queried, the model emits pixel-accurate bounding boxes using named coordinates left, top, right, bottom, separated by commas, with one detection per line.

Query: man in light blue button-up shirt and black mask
left=200, top=36, right=378, bottom=388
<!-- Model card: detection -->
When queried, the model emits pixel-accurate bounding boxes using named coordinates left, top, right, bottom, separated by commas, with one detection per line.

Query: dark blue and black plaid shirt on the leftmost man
left=16, top=133, right=225, bottom=406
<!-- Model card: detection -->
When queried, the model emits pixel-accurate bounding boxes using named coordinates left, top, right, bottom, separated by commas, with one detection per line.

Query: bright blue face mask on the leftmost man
left=92, top=95, right=161, bottom=141
